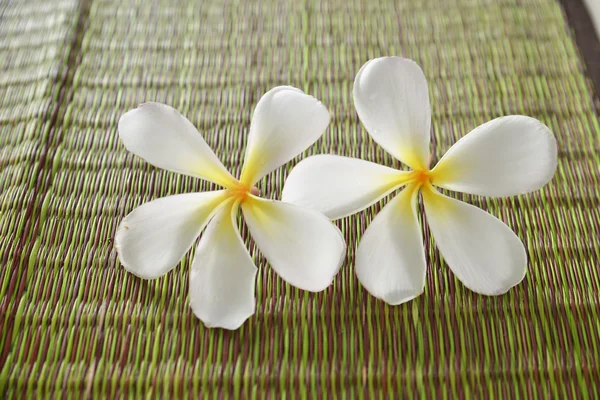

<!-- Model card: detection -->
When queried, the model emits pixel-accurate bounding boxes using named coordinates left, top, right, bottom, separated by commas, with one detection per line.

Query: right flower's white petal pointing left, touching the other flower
left=282, top=154, right=409, bottom=219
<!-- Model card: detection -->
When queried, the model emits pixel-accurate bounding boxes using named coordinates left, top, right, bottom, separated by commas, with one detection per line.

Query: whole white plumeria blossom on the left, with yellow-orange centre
left=115, top=87, right=346, bottom=329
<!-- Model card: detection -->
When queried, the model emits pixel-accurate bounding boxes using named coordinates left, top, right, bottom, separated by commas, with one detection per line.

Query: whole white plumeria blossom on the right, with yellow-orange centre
left=283, top=57, right=557, bottom=304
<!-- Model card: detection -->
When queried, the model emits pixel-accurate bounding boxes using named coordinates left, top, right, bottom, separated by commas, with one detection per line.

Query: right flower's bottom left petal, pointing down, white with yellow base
left=356, top=185, right=426, bottom=305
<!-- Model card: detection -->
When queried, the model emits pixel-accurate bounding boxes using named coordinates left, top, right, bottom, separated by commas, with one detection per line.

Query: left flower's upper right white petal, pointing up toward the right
left=241, top=86, right=329, bottom=187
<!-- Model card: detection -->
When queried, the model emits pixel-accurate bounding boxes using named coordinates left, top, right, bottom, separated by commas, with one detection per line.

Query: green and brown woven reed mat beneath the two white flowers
left=0, top=0, right=600, bottom=398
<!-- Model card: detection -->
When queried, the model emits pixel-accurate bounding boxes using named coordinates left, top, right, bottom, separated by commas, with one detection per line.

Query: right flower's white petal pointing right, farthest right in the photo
left=432, top=115, right=557, bottom=197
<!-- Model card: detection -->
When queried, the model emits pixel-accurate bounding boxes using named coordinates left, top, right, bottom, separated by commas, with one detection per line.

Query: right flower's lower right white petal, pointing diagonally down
left=423, top=187, right=527, bottom=296
